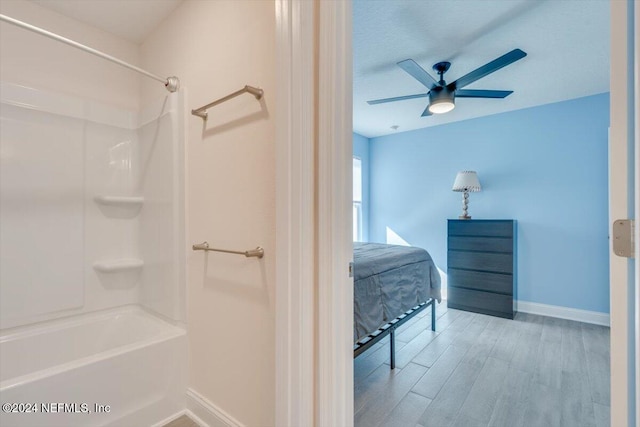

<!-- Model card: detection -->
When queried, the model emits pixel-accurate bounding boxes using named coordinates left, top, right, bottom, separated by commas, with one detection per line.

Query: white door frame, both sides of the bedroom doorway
left=275, top=0, right=640, bottom=427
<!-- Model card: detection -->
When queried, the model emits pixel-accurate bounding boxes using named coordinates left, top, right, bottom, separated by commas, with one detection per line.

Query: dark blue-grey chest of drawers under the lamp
left=447, top=219, right=518, bottom=319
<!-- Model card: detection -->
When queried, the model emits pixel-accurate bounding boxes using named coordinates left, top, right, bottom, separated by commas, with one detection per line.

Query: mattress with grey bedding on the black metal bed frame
left=353, top=243, right=442, bottom=342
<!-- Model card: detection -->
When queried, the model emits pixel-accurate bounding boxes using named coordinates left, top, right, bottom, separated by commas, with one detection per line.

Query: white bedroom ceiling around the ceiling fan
left=353, top=0, right=610, bottom=137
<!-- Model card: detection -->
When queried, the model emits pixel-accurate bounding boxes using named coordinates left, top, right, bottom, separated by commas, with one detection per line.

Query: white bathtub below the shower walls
left=0, top=306, right=187, bottom=427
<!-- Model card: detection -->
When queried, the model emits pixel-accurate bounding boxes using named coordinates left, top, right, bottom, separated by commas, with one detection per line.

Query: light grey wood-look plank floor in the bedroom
left=354, top=302, right=610, bottom=427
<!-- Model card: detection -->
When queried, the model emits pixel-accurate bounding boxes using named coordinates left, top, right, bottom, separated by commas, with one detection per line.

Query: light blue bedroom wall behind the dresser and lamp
left=369, top=93, right=609, bottom=313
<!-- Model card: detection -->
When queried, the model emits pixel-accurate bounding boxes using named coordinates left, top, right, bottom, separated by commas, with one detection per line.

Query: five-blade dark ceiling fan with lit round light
left=367, top=49, right=527, bottom=117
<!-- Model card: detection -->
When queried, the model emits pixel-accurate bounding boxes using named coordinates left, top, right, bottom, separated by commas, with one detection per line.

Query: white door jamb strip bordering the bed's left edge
left=316, top=1, right=353, bottom=427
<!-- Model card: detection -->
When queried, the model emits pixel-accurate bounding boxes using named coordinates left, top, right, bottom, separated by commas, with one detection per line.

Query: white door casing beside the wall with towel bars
left=275, top=0, right=315, bottom=427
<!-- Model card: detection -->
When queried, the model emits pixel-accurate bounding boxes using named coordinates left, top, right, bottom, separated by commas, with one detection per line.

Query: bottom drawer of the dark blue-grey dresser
left=447, top=286, right=513, bottom=319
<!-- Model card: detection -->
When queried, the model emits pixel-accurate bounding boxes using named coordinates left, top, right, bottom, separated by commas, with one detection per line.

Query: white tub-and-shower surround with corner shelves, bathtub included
left=0, top=82, right=186, bottom=426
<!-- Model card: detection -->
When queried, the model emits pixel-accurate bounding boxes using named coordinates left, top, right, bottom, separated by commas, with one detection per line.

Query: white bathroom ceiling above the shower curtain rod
left=31, top=0, right=182, bottom=44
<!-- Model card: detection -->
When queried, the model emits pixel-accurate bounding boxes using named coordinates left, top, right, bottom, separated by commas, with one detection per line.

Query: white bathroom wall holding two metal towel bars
left=141, top=0, right=275, bottom=426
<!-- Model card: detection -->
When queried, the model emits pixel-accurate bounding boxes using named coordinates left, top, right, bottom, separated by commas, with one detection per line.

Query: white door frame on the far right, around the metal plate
left=609, top=1, right=639, bottom=426
